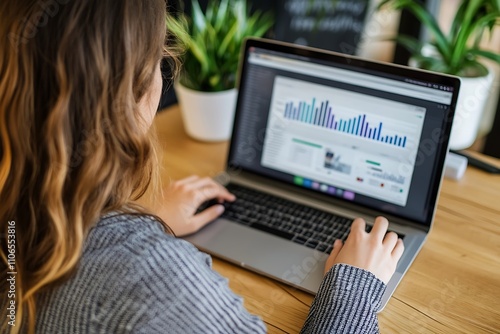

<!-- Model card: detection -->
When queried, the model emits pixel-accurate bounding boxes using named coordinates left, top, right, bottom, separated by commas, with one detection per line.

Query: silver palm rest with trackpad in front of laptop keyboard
left=185, top=219, right=327, bottom=293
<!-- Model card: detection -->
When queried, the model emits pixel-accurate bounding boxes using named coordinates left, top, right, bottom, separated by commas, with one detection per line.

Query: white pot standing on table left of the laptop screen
left=174, top=82, right=237, bottom=141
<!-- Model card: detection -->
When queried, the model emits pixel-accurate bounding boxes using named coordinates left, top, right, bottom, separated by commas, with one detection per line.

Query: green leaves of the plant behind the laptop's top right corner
left=379, top=0, right=500, bottom=77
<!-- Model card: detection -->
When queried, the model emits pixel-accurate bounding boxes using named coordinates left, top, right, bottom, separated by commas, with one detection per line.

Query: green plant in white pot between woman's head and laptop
left=167, top=0, right=273, bottom=141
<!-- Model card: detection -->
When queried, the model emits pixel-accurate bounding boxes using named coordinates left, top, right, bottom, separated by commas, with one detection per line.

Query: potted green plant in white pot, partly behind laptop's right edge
left=379, top=0, right=500, bottom=149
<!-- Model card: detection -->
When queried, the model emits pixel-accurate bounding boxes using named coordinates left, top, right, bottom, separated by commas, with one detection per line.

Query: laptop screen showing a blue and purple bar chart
left=229, top=41, right=459, bottom=223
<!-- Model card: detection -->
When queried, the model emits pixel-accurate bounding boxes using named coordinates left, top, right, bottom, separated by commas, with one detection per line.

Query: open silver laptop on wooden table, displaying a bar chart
left=186, top=39, right=460, bottom=311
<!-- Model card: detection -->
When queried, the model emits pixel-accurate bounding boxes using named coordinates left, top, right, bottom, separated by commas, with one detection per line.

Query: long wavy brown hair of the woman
left=0, top=0, right=175, bottom=333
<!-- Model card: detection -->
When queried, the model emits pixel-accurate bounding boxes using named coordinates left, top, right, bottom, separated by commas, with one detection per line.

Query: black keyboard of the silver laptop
left=222, top=184, right=356, bottom=254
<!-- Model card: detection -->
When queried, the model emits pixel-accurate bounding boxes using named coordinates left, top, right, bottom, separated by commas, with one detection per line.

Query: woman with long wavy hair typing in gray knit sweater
left=0, top=0, right=403, bottom=333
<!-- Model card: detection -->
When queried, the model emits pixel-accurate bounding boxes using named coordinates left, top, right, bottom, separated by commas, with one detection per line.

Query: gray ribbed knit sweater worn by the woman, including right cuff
left=36, top=215, right=385, bottom=334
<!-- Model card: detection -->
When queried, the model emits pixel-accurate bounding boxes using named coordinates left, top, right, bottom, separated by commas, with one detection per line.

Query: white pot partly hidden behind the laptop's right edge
left=450, top=70, right=494, bottom=150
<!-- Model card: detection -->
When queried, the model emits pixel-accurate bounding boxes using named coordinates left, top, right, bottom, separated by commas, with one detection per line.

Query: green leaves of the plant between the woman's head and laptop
left=167, top=0, right=274, bottom=92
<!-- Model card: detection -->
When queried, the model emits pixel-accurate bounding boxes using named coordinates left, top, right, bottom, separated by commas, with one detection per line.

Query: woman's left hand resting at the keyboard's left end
left=158, top=175, right=236, bottom=236
